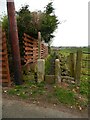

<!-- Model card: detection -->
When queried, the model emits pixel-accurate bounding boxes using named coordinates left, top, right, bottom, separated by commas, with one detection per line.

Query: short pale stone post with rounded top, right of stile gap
left=55, top=59, right=61, bottom=83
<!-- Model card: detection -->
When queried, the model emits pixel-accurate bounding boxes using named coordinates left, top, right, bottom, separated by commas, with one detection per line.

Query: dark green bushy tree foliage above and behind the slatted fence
left=2, top=2, right=59, bottom=56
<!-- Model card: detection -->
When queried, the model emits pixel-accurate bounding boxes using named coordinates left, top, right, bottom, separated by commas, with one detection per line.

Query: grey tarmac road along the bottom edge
left=2, top=96, right=88, bottom=118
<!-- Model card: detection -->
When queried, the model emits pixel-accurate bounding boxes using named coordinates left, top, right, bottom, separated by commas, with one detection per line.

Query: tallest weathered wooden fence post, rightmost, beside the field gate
left=75, top=50, right=82, bottom=85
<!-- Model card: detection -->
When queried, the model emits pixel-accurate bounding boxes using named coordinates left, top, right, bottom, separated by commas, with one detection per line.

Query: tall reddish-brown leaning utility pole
left=7, top=0, right=22, bottom=85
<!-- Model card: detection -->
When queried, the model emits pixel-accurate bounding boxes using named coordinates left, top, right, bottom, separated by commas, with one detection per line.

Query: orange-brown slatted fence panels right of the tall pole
left=23, top=33, right=48, bottom=64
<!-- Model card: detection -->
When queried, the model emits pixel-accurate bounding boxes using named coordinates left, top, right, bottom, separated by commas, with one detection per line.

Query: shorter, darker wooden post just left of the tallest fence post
left=68, top=53, right=75, bottom=77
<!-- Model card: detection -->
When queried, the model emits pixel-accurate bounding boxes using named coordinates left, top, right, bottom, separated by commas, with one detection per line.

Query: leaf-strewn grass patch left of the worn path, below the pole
left=8, top=81, right=45, bottom=99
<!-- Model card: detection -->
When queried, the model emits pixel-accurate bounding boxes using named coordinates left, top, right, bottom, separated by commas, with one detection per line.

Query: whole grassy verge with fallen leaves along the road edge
left=4, top=78, right=87, bottom=107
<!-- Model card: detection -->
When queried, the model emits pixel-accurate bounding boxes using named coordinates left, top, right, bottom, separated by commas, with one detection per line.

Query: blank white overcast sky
left=0, top=0, right=89, bottom=46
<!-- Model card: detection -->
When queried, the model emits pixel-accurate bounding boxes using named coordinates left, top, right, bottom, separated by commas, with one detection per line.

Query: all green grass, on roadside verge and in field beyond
left=3, top=48, right=90, bottom=107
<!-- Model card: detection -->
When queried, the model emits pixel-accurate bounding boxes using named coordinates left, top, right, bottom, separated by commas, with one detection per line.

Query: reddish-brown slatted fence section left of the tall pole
left=0, top=32, right=10, bottom=86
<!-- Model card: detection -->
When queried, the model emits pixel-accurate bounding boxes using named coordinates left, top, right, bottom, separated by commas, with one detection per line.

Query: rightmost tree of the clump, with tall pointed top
left=41, top=2, right=59, bottom=43
